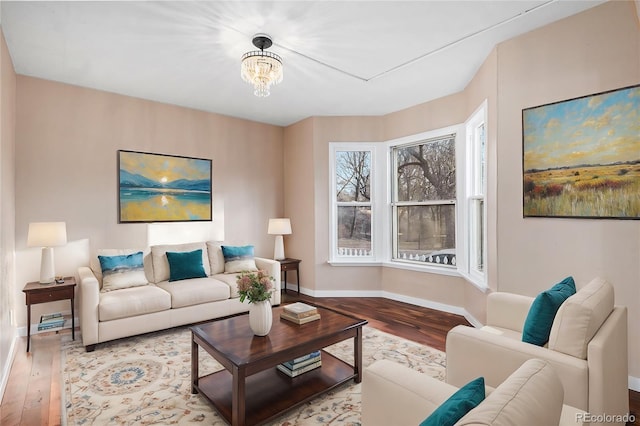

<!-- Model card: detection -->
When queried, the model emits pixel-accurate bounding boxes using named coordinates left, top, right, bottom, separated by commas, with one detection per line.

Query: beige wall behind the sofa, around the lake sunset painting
left=15, top=76, right=284, bottom=326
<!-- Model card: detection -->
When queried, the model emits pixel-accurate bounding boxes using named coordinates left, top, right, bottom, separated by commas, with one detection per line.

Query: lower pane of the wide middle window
left=396, top=204, right=456, bottom=265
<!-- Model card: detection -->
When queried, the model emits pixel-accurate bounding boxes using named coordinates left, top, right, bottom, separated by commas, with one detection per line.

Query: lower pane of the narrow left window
left=338, top=206, right=371, bottom=256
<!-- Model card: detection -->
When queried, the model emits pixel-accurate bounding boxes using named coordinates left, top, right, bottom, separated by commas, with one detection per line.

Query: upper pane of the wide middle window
left=394, top=136, right=456, bottom=201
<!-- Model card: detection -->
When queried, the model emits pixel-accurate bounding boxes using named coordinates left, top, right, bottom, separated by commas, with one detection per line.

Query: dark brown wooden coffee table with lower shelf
left=191, top=307, right=367, bottom=426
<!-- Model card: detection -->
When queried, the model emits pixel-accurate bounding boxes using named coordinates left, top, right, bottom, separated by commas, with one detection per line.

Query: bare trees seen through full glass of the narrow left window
left=335, top=151, right=372, bottom=256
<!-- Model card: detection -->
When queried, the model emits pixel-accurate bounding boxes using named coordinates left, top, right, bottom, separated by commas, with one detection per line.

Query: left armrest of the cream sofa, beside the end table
left=78, top=266, right=100, bottom=346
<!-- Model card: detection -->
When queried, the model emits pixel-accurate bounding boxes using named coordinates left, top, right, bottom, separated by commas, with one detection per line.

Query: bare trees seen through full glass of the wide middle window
left=393, top=135, right=456, bottom=265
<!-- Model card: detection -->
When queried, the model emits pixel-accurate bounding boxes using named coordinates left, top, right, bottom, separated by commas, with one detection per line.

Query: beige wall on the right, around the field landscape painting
left=493, top=2, right=640, bottom=385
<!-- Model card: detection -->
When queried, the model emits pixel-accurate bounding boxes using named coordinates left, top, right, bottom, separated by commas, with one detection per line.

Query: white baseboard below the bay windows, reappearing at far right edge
left=288, top=286, right=640, bottom=392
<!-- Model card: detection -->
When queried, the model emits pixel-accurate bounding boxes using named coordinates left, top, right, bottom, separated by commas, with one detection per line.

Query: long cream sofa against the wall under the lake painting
left=78, top=241, right=280, bottom=352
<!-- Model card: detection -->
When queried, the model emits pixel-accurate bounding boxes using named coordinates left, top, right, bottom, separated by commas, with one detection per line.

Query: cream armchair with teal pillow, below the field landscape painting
left=446, top=278, right=629, bottom=424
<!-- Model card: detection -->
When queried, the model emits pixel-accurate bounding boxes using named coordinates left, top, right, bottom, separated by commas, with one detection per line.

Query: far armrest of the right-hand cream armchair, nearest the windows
left=487, top=292, right=534, bottom=333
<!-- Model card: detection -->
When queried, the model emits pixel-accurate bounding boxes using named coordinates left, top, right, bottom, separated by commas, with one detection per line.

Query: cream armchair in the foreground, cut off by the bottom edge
left=362, top=359, right=586, bottom=426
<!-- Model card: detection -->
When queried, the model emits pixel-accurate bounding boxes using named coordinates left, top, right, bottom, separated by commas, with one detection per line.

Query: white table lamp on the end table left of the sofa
left=27, top=222, right=67, bottom=284
